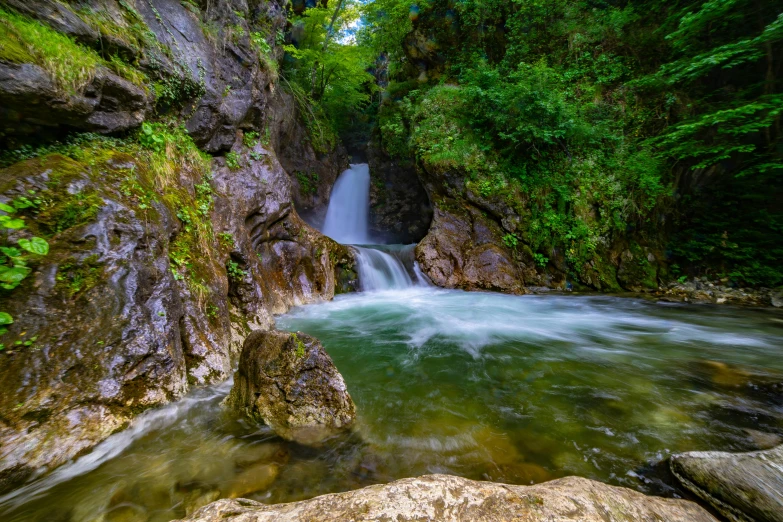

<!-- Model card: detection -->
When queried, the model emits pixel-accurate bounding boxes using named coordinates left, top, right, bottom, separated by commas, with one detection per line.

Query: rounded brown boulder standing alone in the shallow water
left=227, top=331, right=356, bottom=445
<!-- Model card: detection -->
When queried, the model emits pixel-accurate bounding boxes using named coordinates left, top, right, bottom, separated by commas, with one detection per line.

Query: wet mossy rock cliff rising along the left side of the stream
left=0, top=0, right=352, bottom=490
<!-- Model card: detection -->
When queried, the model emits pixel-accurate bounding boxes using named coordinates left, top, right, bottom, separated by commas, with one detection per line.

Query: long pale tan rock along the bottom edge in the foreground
left=176, top=475, right=716, bottom=522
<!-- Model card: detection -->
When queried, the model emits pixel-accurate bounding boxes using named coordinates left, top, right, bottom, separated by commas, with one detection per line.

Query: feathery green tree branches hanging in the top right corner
left=646, top=0, right=783, bottom=176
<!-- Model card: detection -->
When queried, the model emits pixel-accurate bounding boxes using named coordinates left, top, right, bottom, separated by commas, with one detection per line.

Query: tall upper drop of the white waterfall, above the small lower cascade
left=322, top=163, right=371, bottom=245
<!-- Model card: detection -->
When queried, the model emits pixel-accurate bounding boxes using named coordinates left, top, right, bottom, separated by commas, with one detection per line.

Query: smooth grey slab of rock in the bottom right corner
left=671, top=446, right=783, bottom=522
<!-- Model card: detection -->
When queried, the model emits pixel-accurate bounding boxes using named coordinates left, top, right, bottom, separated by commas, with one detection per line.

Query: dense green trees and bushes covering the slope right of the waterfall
left=283, top=0, right=783, bottom=286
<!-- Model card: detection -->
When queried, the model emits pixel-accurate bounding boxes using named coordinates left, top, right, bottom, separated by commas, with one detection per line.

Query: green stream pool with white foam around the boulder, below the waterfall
left=0, top=287, right=783, bottom=522
